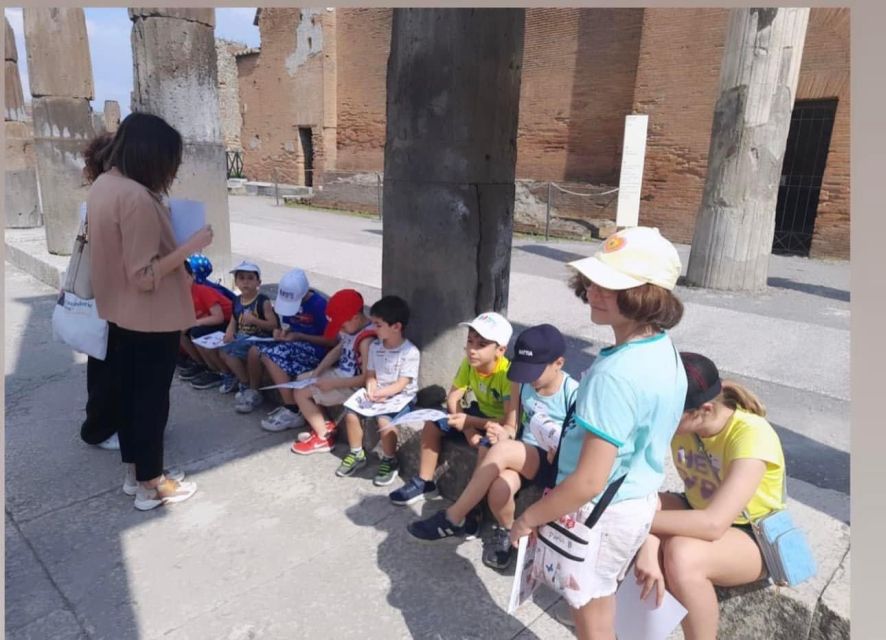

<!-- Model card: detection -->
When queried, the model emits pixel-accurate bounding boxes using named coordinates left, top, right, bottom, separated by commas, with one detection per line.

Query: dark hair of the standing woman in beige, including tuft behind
left=84, top=112, right=183, bottom=193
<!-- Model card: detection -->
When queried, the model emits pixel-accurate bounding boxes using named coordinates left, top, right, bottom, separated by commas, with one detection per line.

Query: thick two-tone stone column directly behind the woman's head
left=129, top=8, right=231, bottom=279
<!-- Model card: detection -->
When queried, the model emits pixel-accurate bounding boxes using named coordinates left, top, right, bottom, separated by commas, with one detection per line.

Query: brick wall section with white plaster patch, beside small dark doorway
left=238, top=8, right=324, bottom=184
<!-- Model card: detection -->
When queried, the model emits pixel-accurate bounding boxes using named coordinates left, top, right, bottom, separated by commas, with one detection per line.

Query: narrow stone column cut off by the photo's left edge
left=3, top=18, right=43, bottom=227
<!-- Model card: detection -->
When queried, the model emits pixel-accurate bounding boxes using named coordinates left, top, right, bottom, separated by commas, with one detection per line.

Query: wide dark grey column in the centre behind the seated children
left=382, top=9, right=524, bottom=388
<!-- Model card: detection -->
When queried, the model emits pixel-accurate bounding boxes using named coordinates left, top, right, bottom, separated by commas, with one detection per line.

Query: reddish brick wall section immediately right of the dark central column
left=517, top=9, right=643, bottom=184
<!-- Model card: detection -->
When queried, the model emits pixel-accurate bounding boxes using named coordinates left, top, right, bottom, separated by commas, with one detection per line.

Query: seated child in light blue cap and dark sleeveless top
left=218, top=261, right=278, bottom=406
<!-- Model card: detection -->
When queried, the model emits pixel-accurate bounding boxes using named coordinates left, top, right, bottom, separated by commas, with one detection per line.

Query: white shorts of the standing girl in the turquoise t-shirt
left=563, top=492, right=658, bottom=609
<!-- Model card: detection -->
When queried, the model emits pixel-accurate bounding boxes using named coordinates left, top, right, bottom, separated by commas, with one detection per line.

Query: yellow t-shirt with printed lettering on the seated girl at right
left=671, top=409, right=785, bottom=524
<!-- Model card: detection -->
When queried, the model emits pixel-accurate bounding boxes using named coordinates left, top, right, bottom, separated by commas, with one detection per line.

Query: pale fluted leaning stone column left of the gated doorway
left=686, top=8, right=809, bottom=291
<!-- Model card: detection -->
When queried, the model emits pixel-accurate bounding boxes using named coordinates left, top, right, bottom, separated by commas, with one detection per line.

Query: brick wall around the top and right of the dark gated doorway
left=797, top=8, right=851, bottom=259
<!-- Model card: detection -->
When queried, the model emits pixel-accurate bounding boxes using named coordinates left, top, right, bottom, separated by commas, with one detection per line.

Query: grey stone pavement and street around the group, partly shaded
left=5, top=196, right=849, bottom=640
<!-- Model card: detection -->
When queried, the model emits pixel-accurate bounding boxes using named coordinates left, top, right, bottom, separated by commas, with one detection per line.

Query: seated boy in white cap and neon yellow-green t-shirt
left=389, top=312, right=517, bottom=510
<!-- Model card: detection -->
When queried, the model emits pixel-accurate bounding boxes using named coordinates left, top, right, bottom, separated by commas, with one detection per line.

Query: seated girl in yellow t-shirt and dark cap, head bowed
left=634, top=353, right=785, bottom=640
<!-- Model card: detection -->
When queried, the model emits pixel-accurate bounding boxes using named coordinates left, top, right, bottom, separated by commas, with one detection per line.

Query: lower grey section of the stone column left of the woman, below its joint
left=34, top=98, right=95, bottom=255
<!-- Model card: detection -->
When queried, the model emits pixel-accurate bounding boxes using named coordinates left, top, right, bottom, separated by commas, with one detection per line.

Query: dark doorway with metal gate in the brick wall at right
left=772, top=99, right=837, bottom=256
